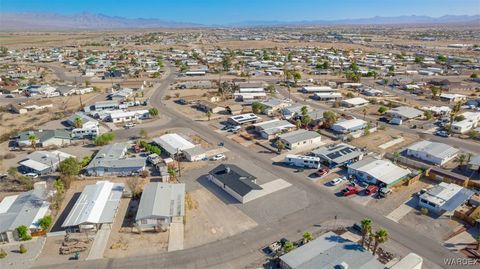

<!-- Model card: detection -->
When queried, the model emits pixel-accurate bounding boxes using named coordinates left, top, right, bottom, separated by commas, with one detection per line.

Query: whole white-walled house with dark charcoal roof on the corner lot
left=208, top=164, right=262, bottom=204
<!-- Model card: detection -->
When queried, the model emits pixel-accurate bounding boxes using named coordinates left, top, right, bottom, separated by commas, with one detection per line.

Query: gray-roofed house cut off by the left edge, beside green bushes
left=0, top=182, right=50, bottom=243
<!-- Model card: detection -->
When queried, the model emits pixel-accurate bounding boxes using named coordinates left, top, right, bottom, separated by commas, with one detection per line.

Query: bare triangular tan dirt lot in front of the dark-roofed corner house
left=185, top=188, right=257, bottom=248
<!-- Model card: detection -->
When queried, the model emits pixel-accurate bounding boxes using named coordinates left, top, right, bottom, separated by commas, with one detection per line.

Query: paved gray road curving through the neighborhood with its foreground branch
left=34, top=65, right=465, bottom=269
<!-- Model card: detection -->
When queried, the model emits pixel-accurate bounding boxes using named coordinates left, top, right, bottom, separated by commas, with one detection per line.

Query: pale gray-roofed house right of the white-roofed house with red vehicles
left=406, top=140, right=460, bottom=165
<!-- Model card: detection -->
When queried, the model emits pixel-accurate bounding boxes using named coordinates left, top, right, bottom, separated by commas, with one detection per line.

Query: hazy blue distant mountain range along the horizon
left=0, top=12, right=480, bottom=31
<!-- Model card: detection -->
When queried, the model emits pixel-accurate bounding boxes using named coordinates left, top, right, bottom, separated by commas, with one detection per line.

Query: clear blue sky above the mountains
left=0, top=0, right=480, bottom=24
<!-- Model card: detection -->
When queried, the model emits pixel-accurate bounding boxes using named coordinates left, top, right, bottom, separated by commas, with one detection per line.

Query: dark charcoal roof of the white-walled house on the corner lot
left=209, top=164, right=262, bottom=196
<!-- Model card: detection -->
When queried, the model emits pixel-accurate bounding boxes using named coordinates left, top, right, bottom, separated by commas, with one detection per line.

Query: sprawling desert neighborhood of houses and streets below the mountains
left=0, top=12, right=480, bottom=269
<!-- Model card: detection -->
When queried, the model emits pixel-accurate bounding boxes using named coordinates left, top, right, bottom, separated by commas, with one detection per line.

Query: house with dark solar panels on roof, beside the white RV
left=312, top=143, right=363, bottom=167
